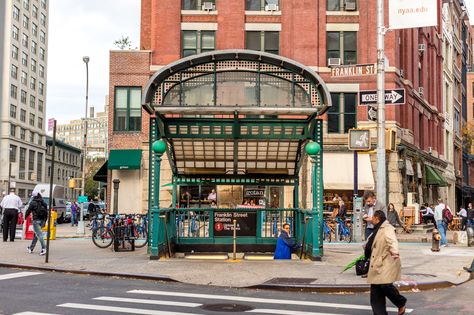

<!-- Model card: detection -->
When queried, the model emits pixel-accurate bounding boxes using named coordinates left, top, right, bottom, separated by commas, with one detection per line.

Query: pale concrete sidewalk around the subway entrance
left=0, top=226, right=474, bottom=292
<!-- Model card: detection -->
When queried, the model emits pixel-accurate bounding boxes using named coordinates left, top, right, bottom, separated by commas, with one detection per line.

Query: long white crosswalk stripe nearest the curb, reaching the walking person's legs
left=127, top=290, right=413, bottom=313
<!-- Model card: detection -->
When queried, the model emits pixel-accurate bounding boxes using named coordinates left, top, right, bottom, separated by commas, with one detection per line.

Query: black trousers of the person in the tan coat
left=370, top=283, right=407, bottom=315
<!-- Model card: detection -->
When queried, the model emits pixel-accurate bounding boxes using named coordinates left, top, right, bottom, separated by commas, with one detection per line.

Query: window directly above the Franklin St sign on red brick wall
left=326, top=32, right=357, bottom=65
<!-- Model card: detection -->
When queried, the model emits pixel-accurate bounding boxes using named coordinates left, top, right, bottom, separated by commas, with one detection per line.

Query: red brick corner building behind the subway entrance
left=108, top=0, right=446, bottom=210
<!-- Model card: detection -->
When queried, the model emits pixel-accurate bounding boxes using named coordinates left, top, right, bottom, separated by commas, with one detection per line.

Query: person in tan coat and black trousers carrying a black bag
left=364, top=210, right=407, bottom=315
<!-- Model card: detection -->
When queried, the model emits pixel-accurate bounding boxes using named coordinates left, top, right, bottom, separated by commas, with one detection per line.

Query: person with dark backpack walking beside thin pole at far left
left=25, top=191, right=48, bottom=256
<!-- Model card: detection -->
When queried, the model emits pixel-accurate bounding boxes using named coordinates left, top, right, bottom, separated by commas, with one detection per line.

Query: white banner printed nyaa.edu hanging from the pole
left=388, top=0, right=439, bottom=30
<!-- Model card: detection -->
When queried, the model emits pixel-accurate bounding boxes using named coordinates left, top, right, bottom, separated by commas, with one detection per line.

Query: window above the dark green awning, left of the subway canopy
left=114, top=87, right=142, bottom=131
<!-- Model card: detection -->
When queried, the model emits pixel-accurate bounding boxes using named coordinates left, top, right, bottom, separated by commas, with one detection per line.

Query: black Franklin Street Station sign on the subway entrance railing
left=214, top=211, right=257, bottom=237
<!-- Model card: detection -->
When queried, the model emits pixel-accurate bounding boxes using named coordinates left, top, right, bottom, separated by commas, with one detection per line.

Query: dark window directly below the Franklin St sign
left=328, top=93, right=357, bottom=133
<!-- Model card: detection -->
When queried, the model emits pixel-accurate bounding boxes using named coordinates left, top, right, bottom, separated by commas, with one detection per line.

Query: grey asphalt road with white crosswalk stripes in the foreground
left=0, top=268, right=474, bottom=315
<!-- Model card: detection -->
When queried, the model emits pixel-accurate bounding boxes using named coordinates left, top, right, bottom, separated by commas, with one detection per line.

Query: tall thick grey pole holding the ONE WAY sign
left=376, top=0, right=387, bottom=205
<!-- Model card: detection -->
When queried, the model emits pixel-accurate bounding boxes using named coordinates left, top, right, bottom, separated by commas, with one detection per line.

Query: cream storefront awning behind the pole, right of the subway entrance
left=323, top=152, right=375, bottom=190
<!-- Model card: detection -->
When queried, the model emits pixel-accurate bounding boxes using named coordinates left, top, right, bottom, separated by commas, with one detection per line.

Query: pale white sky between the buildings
left=46, top=0, right=474, bottom=124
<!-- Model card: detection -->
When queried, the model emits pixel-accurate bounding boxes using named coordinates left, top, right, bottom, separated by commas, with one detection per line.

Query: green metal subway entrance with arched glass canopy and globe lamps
left=143, top=50, right=331, bottom=259
